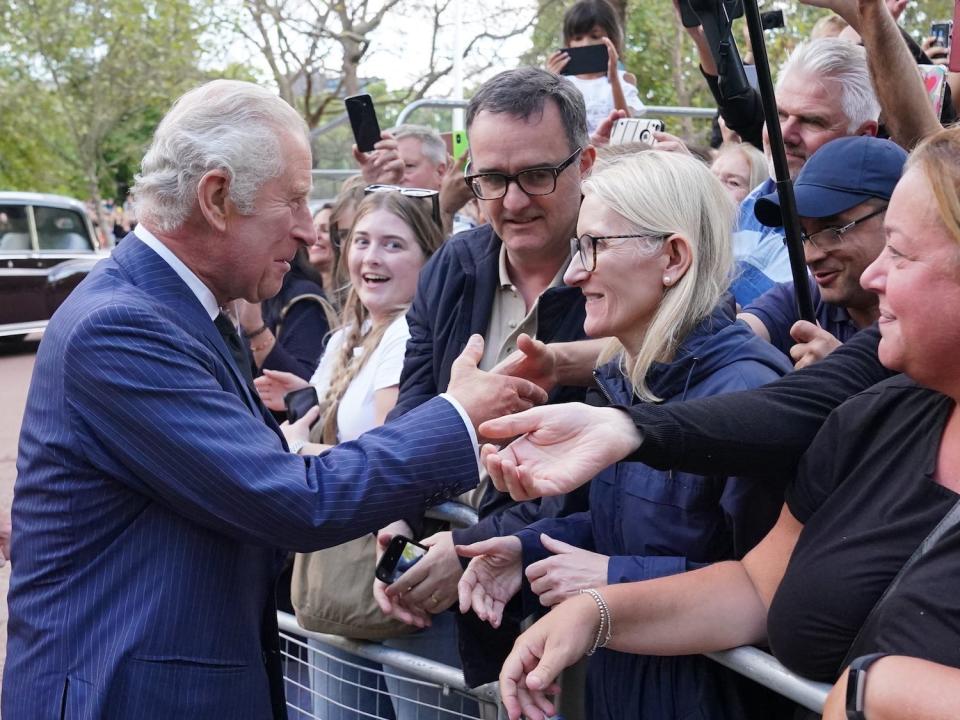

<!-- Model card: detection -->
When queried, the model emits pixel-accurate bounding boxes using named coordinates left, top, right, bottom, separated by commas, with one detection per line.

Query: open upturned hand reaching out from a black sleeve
left=478, top=403, right=641, bottom=502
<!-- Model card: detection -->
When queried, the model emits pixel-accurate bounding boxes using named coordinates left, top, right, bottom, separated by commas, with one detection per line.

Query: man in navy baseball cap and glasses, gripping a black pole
left=740, top=135, right=907, bottom=368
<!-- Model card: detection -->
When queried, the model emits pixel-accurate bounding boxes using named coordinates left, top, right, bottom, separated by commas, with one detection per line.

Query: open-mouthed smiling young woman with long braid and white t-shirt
left=257, top=192, right=443, bottom=720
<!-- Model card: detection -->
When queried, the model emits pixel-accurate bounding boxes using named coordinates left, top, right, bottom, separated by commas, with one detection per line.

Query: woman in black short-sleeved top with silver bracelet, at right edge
left=492, top=128, right=960, bottom=718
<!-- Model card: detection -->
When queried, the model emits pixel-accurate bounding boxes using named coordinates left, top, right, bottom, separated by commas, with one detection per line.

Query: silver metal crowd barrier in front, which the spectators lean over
left=277, top=502, right=830, bottom=720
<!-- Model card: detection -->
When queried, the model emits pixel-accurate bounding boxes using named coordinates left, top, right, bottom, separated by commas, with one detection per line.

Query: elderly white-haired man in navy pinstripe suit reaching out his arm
left=2, top=81, right=545, bottom=720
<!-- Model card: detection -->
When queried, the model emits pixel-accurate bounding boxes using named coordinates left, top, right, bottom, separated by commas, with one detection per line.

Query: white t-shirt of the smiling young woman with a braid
left=310, top=315, right=410, bottom=442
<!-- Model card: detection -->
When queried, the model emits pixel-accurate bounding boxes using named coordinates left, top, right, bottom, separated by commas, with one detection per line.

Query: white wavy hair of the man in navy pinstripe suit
left=133, top=80, right=309, bottom=232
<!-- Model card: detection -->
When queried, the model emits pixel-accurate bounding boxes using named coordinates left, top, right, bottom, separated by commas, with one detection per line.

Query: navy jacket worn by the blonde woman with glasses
left=516, top=303, right=790, bottom=719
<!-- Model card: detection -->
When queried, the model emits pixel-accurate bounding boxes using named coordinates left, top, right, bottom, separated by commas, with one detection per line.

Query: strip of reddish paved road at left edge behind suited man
left=0, top=334, right=39, bottom=688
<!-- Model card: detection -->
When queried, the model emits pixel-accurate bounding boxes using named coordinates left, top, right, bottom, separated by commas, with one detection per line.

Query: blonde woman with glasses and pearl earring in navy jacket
left=460, top=150, right=790, bottom=719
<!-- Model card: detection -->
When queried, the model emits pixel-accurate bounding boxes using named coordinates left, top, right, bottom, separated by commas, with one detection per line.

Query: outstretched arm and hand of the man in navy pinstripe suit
left=65, top=306, right=546, bottom=551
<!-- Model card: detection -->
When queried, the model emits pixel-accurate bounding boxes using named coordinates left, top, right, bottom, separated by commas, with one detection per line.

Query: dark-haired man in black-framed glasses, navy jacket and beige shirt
left=377, top=68, right=596, bottom=696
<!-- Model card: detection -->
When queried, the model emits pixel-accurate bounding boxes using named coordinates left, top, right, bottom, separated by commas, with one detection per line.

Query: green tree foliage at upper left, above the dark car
left=0, top=0, right=218, bottom=202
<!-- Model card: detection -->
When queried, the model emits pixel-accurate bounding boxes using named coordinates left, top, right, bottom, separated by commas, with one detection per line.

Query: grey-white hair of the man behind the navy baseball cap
left=777, top=37, right=880, bottom=133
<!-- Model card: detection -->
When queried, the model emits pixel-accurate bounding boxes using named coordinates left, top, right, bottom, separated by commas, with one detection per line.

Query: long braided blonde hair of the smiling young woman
left=316, top=192, right=443, bottom=445
